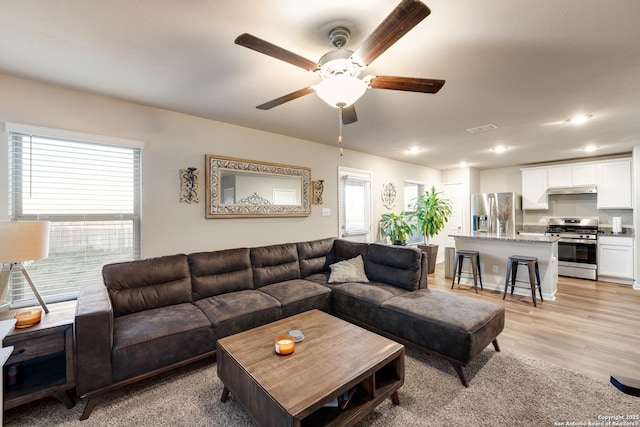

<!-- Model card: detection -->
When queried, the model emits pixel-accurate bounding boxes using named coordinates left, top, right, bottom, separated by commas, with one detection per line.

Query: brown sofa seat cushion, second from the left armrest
left=194, top=290, right=280, bottom=338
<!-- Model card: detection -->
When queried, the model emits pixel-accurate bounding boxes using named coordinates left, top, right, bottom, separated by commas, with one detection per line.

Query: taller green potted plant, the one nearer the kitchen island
left=413, top=186, right=451, bottom=274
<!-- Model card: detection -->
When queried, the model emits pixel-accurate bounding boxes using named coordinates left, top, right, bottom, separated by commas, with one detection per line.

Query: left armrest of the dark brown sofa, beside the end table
left=75, top=283, right=113, bottom=397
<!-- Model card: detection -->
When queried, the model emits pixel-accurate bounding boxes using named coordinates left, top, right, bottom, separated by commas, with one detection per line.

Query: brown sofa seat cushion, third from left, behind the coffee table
left=259, top=279, right=331, bottom=317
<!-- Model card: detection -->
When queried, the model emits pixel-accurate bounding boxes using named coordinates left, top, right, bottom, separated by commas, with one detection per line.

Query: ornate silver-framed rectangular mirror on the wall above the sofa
left=205, top=154, right=311, bottom=218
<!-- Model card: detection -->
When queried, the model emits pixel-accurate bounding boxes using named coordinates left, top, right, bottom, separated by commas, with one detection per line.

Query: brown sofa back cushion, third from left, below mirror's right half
left=251, top=243, right=300, bottom=288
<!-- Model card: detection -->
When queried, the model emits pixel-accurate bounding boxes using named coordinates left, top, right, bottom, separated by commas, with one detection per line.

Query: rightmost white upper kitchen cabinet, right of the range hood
left=596, top=159, right=633, bottom=209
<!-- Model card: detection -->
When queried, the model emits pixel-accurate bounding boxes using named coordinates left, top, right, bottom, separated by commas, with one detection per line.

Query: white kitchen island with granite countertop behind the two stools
left=452, top=232, right=560, bottom=300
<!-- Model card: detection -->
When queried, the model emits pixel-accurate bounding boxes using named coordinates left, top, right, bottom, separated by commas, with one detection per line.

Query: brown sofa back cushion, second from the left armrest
left=189, top=248, right=253, bottom=301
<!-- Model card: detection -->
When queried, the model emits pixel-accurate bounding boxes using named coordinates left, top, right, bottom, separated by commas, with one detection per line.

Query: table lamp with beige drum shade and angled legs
left=0, top=221, right=49, bottom=313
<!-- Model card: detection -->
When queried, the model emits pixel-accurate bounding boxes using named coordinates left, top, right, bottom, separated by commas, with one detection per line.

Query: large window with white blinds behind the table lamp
left=6, top=123, right=142, bottom=307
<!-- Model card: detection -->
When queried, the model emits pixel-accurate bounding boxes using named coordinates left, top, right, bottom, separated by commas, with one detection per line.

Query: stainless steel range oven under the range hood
left=545, top=218, right=598, bottom=280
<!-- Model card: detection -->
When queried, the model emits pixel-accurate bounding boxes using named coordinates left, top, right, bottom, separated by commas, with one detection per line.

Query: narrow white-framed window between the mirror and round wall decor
left=338, top=168, right=371, bottom=241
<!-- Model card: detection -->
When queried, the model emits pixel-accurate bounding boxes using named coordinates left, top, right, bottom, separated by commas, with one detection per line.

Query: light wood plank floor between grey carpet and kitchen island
left=429, top=263, right=640, bottom=381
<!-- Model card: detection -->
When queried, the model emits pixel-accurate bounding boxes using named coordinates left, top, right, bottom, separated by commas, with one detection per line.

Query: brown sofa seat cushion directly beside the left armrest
left=111, top=303, right=216, bottom=382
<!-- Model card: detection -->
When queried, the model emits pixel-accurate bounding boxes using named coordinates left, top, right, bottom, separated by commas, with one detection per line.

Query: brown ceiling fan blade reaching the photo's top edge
left=352, top=0, right=431, bottom=67
